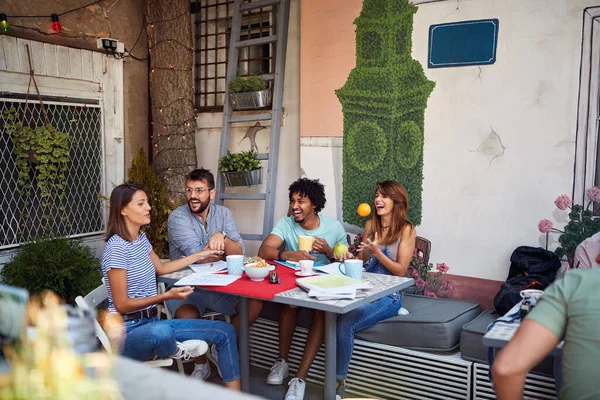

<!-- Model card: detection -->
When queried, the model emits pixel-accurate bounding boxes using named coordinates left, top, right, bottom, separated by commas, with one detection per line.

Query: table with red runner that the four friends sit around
left=158, top=264, right=414, bottom=400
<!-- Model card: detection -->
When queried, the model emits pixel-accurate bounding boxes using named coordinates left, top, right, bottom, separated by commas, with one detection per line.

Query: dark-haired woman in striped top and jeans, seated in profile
left=102, top=183, right=240, bottom=390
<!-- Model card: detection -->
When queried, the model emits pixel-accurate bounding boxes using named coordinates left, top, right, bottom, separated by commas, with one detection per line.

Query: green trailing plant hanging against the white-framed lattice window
left=4, top=108, right=70, bottom=220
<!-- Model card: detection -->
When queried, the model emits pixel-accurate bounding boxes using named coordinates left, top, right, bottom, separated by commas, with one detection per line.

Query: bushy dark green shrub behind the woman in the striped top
left=0, top=237, right=102, bottom=304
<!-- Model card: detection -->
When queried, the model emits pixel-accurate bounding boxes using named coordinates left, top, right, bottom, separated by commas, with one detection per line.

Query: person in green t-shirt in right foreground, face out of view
left=492, top=269, right=600, bottom=400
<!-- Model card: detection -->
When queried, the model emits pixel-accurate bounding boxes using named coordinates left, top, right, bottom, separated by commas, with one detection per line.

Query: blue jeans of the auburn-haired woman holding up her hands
left=335, top=293, right=402, bottom=380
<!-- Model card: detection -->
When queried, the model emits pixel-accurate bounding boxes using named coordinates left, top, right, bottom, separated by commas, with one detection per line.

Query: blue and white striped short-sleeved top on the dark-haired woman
left=102, top=232, right=157, bottom=312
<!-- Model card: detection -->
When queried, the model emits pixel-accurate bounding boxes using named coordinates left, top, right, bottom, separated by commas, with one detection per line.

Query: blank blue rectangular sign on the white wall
left=427, top=19, right=499, bottom=68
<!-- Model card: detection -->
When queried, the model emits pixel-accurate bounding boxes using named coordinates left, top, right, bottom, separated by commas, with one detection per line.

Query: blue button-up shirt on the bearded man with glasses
left=168, top=204, right=245, bottom=260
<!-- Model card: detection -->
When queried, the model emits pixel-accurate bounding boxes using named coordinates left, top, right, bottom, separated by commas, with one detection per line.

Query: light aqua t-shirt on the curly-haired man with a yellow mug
left=271, top=215, right=348, bottom=264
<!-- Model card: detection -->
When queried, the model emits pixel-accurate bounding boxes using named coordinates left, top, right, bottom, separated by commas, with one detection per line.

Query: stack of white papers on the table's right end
left=296, top=274, right=373, bottom=300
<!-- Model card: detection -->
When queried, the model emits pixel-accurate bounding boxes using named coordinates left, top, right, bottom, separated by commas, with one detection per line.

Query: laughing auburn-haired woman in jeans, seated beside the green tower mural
left=336, top=181, right=416, bottom=397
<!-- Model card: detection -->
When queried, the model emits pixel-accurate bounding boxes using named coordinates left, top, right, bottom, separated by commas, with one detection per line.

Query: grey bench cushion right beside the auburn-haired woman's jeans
left=356, top=295, right=480, bottom=351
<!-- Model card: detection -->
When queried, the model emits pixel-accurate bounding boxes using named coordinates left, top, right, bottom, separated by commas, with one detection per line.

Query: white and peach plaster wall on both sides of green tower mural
left=301, top=0, right=597, bottom=280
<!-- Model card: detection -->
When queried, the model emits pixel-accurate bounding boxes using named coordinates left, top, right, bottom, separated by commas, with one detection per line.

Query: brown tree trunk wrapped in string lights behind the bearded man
left=146, top=0, right=198, bottom=200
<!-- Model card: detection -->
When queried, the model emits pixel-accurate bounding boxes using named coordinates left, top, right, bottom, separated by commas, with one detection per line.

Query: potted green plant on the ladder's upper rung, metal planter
left=229, top=75, right=271, bottom=110
